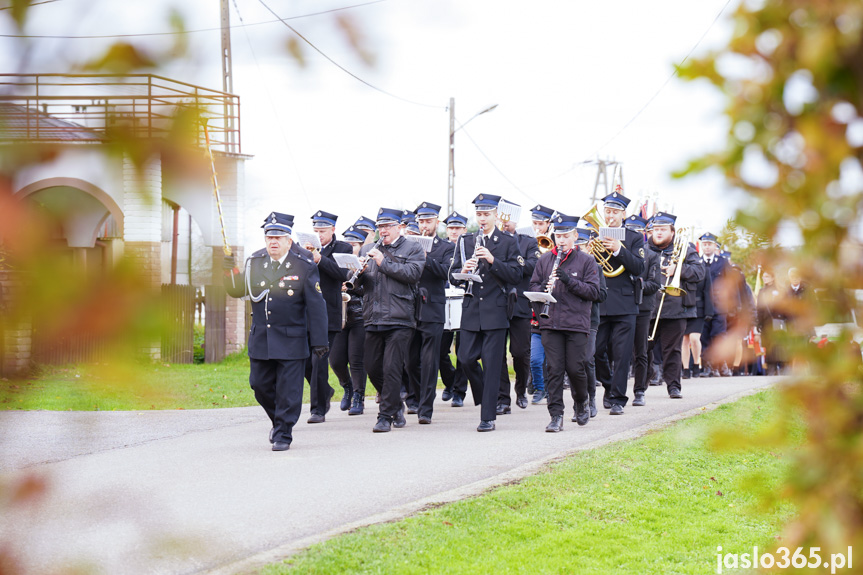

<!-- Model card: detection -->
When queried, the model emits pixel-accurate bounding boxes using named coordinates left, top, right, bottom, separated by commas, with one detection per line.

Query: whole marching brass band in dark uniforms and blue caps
left=225, top=185, right=744, bottom=450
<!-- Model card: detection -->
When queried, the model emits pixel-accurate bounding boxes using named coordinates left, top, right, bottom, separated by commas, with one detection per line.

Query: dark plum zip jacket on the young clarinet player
left=530, top=248, right=600, bottom=333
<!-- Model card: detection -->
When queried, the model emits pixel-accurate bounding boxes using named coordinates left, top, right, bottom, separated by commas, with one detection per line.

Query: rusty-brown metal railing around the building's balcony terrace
left=0, top=74, right=242, bottom=153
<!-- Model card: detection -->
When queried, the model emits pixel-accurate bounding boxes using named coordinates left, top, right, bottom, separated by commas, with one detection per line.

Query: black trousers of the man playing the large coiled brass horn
left=596, top=314, right=635, bottom=407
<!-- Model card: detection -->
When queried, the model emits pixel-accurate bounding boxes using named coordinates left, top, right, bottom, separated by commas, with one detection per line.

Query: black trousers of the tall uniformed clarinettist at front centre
left=458, top=329, right=506, bottom=421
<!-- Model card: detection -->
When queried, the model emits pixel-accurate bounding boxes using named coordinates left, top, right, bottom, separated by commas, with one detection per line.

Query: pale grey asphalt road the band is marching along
left=0, top=377, right=780, bottom=575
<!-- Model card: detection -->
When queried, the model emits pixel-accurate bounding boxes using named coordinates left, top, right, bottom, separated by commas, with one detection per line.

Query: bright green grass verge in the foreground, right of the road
left=263, top=392, right=802, bottom=575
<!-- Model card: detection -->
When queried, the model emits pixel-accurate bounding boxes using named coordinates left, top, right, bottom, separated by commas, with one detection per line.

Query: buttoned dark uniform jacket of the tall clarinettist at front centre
left=450, top=228, right=523, bottom=331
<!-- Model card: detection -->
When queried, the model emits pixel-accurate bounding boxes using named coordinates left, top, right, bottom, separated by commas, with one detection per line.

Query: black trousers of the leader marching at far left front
left=249, top=359, right=306, bottom=443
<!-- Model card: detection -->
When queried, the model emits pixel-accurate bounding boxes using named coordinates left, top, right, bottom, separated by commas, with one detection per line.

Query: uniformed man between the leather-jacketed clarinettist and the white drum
left=406, top=202, right=455, bottom=424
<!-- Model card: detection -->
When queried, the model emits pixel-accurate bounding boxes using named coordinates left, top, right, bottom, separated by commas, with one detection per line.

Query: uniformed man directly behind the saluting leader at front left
left=303, top=210, right=353, bottom=423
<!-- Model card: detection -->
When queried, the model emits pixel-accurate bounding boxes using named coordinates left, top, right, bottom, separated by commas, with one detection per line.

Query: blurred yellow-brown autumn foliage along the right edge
left=679, top=0, right=863, bottom=572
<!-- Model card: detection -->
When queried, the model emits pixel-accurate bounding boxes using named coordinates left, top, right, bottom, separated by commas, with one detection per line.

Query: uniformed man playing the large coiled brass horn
left=596, top=186, right=644, bottom=415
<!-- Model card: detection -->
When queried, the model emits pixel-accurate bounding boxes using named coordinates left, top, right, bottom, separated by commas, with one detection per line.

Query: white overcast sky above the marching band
left=0, top=0, right=743, bottom=251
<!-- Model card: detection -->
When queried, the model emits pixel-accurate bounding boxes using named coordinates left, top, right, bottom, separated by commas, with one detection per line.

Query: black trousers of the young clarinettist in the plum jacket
left=542, top=329, right=590, bottom=417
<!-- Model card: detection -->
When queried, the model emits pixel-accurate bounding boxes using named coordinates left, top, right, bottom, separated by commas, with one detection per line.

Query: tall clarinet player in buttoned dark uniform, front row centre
left=450, top=194, right=524, bottom=431
